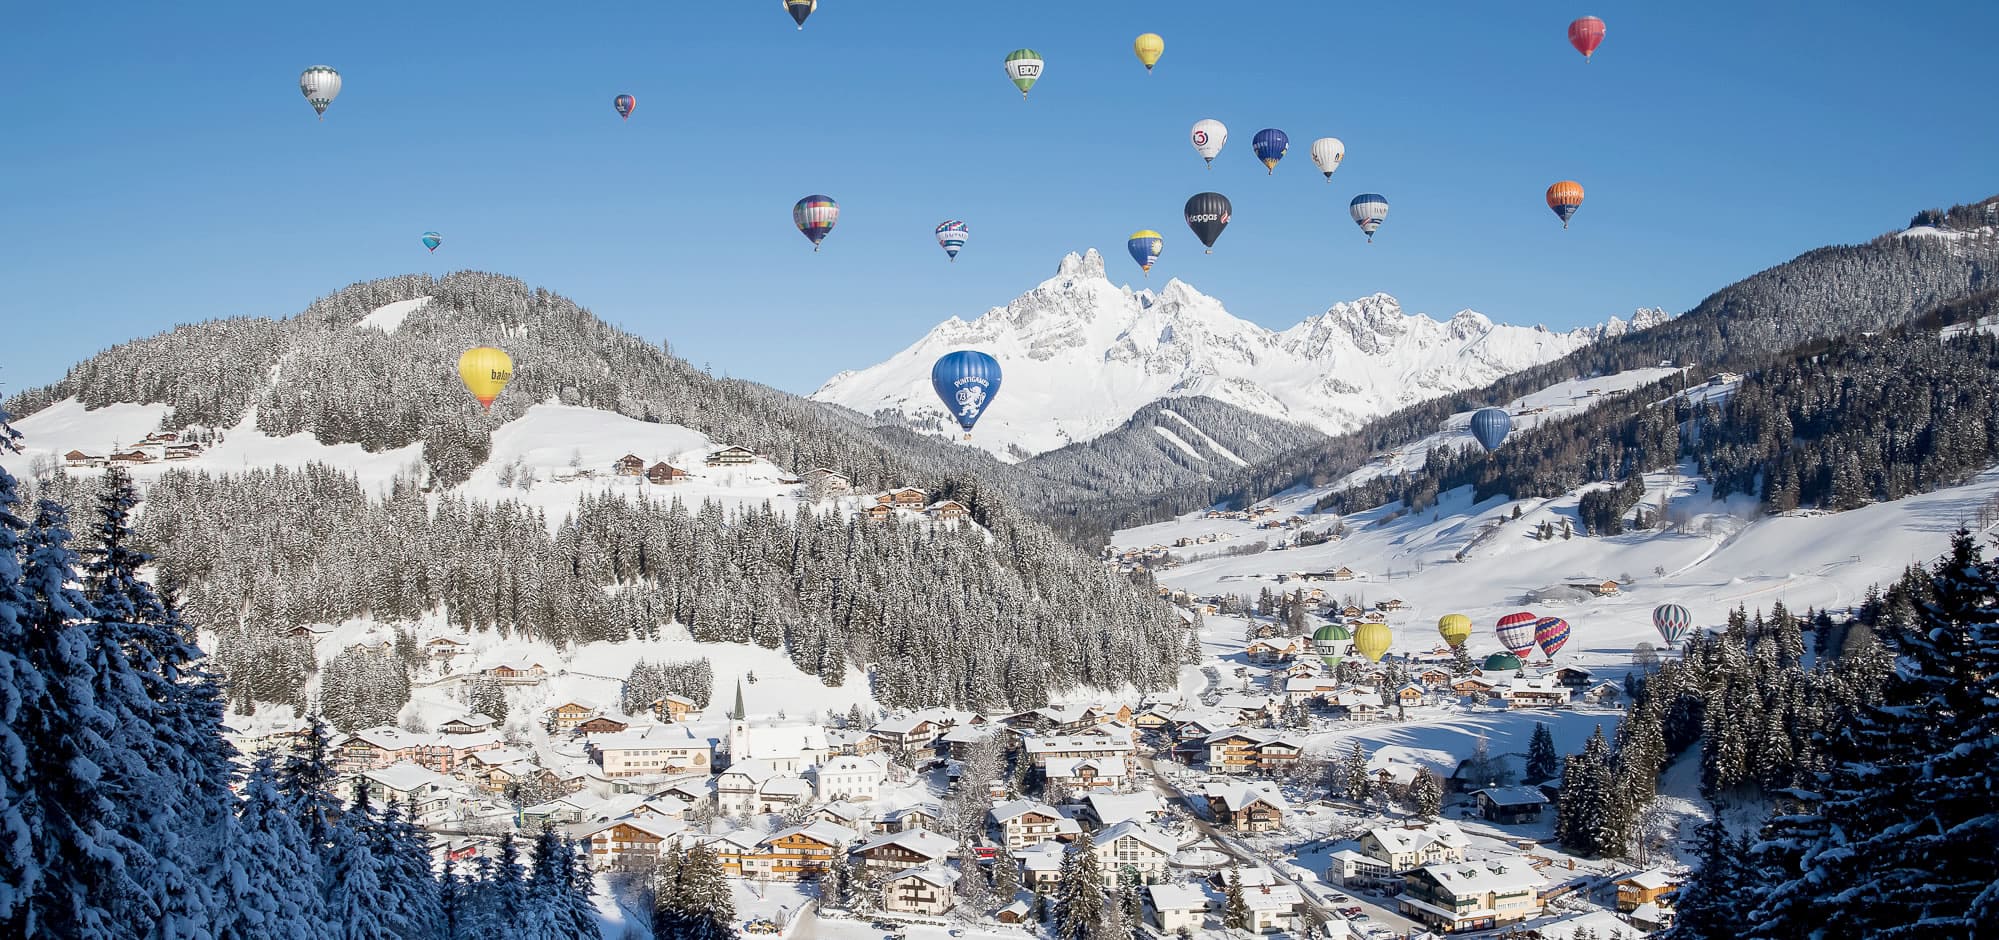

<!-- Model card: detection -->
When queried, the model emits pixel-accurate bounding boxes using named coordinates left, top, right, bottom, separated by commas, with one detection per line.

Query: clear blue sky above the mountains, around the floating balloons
left=0, top=0, right=1999, bottom=392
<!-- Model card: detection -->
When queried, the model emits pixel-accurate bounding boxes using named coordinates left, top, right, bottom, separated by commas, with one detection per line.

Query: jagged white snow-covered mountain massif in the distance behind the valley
left=812, top=248, right=1667, bottom=458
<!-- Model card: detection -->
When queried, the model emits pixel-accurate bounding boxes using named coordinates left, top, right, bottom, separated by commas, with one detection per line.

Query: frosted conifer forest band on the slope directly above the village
left=31, top=458, right=1187, bottom=708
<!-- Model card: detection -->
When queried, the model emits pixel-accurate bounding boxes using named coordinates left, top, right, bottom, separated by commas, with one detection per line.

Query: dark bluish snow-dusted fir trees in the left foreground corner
left=0, top=450, right=598, bottom=940
